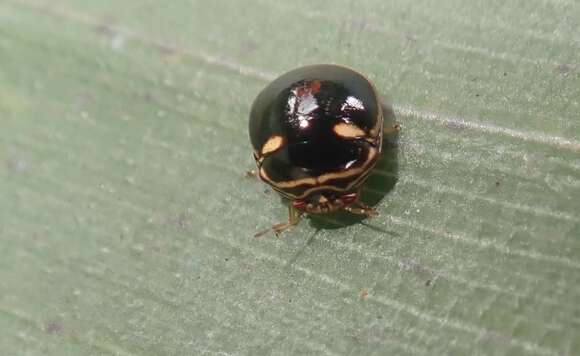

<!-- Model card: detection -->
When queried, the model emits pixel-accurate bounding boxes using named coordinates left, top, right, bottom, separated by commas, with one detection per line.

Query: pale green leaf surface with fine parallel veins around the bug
left=0, top=0, right=580, bottom=356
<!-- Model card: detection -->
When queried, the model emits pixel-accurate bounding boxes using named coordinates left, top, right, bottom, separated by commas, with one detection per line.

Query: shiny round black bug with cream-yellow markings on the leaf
left=249, top=64, right=399, bottom=237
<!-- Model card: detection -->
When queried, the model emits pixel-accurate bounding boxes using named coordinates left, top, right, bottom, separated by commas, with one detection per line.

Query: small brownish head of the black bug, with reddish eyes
left=292, top=191, right=358, bottom=214
